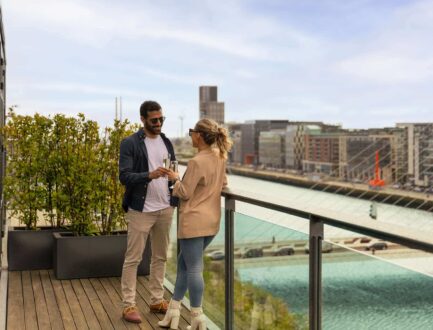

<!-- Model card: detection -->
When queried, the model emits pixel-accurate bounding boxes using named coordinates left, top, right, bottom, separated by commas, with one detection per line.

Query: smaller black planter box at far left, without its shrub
left=8, top=227, right=65, bottom=271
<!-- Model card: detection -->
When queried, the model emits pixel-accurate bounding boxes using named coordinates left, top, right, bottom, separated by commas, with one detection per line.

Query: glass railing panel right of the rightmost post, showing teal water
left=322, top=241, right=433, bottom=330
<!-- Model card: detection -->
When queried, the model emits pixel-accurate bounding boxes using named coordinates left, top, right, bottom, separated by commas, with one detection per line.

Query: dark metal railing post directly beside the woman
left=224, top=197, right=236, bottom=330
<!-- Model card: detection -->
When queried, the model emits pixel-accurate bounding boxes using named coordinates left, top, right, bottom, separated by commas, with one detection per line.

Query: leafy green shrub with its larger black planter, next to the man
left=54, top=120, right=150, bottom=279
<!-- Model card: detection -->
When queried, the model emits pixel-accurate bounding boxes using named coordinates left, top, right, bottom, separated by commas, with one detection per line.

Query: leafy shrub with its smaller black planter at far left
left=1, top=109, right=69, bottom=270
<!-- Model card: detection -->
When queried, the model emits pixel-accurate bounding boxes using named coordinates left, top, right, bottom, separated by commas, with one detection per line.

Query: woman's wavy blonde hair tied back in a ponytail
left=194, top=118, right=233, bottom=159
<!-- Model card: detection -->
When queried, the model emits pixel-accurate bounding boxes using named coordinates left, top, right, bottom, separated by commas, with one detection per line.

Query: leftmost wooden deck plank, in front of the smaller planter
left=7, top=272, right=25, bottom=330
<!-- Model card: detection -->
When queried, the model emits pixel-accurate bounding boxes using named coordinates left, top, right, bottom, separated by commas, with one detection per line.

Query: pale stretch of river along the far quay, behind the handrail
left=224, top=175, right=433, bottom=238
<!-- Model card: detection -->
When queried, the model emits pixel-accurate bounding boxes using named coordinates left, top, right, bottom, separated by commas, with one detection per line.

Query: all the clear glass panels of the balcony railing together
left=167, top=192, right=433, bottom=329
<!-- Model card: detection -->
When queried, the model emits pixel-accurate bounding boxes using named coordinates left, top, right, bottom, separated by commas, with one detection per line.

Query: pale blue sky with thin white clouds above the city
left=2, top=0, right=433, bottom=137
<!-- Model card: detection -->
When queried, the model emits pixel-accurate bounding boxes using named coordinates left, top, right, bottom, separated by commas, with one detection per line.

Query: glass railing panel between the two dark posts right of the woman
left=234, top=213, right=308, bottom=329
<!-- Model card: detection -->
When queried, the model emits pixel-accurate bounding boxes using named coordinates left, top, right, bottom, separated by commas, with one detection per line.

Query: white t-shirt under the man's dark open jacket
left=143, top=135, right=170, bottom=212
